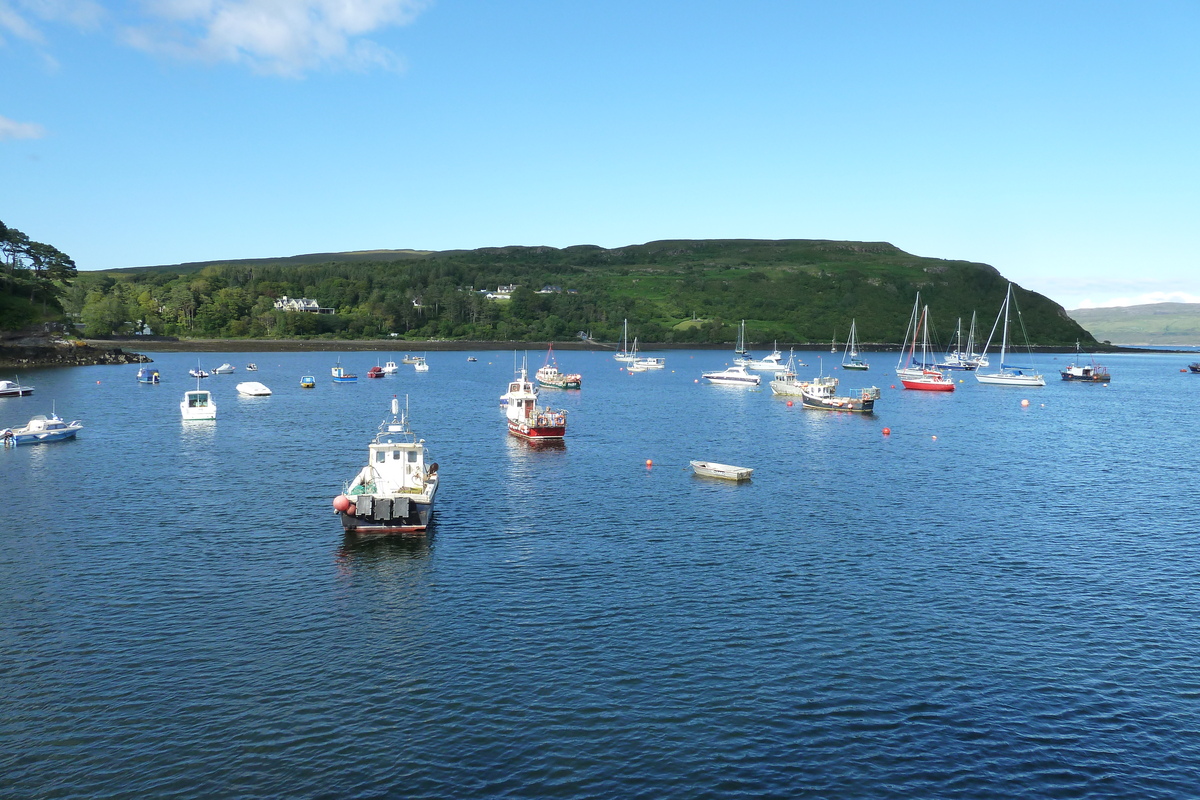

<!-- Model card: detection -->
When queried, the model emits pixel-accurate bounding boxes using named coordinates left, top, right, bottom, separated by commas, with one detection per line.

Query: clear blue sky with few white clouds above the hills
left=0, top=0, right=1200, bottom=308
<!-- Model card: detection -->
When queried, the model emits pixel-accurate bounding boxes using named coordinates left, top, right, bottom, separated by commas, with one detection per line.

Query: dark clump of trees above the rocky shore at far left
left=0, top=222, right=76, bottom=331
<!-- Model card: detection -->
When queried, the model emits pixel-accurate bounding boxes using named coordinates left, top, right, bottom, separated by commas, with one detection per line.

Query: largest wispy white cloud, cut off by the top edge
left=124, top=0, right=426, bottom=76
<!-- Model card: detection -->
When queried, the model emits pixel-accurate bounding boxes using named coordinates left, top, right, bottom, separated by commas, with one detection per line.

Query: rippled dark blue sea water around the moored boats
left=0, top=351, right=1200, bottom=798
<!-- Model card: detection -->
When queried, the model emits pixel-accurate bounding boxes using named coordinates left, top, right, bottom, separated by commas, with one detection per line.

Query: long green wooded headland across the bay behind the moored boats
left=9, top=231, right=1093, bottom=345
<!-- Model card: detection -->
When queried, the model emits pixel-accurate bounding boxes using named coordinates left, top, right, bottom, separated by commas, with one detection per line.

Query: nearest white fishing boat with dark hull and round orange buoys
left=334, top=397, right=438, bottom=534
